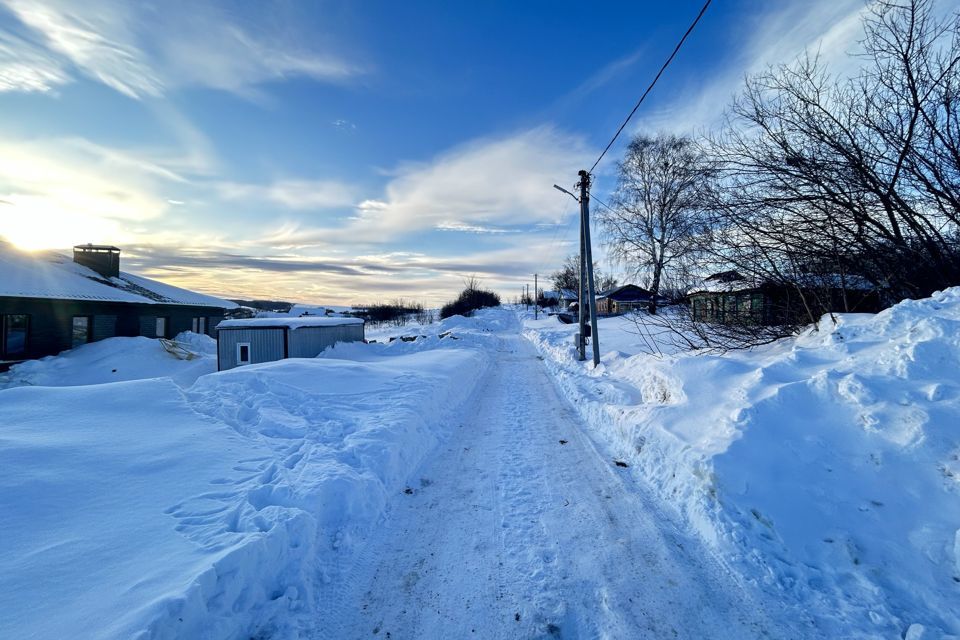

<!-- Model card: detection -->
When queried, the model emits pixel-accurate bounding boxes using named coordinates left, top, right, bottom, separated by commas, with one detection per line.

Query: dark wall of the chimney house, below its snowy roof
left=0, top=297, right=223, bottom=360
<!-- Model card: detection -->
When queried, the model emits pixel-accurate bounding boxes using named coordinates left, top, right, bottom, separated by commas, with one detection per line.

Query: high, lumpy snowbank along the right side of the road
left=525, top=288, right=960, bottom=638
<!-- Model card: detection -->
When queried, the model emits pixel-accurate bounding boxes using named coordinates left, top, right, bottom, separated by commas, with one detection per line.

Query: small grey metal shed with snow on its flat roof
left=217, top=316, right=364, bottom=371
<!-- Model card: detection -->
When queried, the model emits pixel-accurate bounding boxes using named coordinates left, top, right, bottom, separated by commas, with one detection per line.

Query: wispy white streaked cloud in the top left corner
left=0, top=0, right=362, bottom=98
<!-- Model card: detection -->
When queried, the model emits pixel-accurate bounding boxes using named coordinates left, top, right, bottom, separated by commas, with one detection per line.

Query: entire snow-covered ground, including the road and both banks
left=0, top=296, right=960, bottom=640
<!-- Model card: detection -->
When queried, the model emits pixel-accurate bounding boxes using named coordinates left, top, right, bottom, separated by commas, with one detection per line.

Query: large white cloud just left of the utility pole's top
left=354, top=127, right=589, bottom=237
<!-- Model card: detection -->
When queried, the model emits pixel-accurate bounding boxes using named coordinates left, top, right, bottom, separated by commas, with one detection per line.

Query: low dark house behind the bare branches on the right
left=687, top=271, right=882, bottom=325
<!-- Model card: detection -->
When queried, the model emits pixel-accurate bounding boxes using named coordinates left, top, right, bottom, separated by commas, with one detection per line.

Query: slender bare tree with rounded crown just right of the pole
left=597, top=134, right=711, bottom=313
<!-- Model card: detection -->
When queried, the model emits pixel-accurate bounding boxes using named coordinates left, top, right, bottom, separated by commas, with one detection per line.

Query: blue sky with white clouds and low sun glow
left=0, top=0, right=865, bottom=305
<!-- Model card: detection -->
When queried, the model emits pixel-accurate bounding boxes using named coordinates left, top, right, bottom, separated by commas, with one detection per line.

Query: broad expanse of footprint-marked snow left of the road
left=0, top=318, right=487, bottom=638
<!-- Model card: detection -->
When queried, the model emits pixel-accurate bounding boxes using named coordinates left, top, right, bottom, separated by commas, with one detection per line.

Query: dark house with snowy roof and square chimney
left=0, top=243, right=237, bottom=368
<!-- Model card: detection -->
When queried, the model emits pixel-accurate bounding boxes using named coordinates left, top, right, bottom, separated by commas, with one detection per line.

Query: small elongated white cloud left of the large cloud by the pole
left=217, top=180, right=357, bottom=210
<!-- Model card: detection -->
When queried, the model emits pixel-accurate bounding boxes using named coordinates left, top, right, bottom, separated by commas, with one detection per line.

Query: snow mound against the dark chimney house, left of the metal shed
left=0, top=332, right=217, bottom=389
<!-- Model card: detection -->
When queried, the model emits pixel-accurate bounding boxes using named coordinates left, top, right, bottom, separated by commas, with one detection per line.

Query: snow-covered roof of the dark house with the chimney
left=0, top=242, right=237, bottom=309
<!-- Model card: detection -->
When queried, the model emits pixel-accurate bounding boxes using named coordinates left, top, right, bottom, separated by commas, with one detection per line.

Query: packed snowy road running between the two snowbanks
left=317, top=316, right=802, bottom=639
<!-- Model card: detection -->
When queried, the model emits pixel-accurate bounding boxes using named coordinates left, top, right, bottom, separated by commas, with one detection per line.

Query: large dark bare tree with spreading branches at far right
left=710, top=0, right=960, bottom=308
